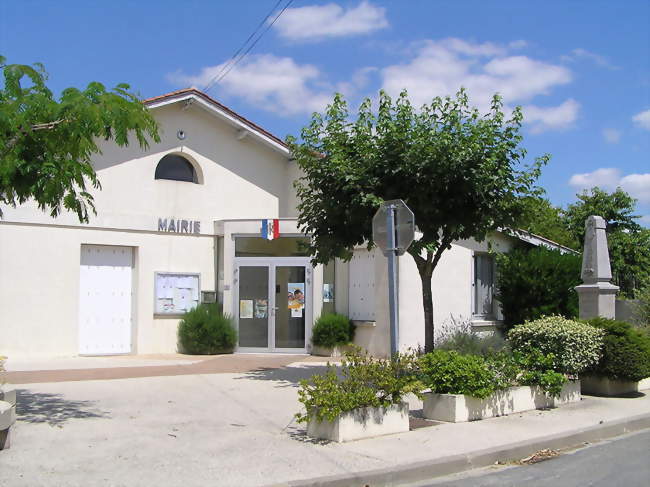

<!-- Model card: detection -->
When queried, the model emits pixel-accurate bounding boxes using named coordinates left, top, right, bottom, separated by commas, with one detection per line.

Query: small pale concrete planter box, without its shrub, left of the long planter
left=307, top=402, right=409, bottom=443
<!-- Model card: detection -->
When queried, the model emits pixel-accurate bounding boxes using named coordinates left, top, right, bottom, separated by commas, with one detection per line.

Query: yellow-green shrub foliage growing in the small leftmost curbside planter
left=296, top=347, right=423, bottom=422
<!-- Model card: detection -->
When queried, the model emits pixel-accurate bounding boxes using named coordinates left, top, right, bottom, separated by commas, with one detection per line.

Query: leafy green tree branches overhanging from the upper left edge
left=0, top=56, right=160, bottom=222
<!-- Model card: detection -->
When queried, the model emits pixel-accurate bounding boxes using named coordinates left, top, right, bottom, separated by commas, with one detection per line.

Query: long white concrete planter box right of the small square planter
left=423, top=381, right=580, bottom=423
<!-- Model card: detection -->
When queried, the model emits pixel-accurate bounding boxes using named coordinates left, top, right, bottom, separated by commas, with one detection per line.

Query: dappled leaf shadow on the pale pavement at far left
left=16, top=389, right=110, bottom=426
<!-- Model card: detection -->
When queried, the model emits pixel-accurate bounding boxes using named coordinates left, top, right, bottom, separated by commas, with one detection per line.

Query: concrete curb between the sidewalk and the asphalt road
left=274, top=414, right=650, bottom=487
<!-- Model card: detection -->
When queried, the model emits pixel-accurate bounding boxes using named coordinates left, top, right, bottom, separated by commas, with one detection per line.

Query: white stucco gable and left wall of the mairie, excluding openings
left=0, top=96, right=296, bottom=356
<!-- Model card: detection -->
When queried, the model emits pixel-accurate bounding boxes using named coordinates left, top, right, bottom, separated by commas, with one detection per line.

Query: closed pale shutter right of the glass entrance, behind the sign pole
left=349, top=249, right=375, bottom=321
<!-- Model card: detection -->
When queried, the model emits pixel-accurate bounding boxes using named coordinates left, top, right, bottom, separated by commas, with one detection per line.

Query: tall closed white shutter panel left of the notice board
left=79, top=245, right=133, bottom=355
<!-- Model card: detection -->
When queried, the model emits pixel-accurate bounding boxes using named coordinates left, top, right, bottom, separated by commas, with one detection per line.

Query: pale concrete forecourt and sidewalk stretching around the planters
left=0, top=362, right=650, bottom=487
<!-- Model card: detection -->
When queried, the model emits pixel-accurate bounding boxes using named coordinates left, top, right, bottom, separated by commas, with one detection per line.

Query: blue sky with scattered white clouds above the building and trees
left=0, top=0, right=650, bottom=226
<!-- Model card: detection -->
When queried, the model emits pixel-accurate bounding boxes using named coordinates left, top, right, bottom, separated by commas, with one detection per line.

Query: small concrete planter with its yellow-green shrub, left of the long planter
left=296, top=347, right=422, bottom=442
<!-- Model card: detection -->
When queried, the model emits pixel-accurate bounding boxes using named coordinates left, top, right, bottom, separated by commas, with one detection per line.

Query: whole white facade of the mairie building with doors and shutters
left=0, top=89, right=560, bottom=356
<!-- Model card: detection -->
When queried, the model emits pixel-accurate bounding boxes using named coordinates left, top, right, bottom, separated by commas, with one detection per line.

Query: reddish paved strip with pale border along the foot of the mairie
left=0, top=354, right=337, bottom=384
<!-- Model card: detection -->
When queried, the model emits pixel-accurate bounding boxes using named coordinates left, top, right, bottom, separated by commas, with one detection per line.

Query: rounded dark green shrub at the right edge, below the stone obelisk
left=581, top=318, right=650, bottom=396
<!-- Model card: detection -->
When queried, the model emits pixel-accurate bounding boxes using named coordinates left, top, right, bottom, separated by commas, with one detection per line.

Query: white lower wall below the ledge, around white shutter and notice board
left=0, top=224, right=214, bottom=357
